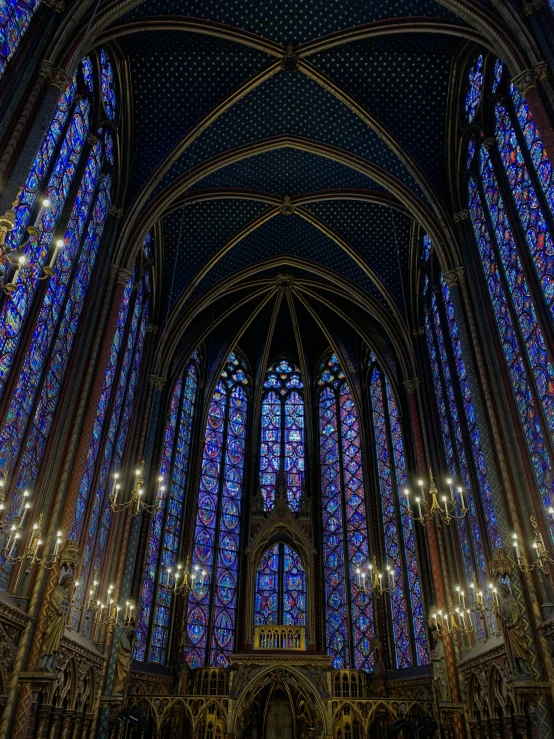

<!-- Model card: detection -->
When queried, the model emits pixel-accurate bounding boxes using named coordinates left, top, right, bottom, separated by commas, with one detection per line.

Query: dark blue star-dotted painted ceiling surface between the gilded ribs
left=104, top=0, right=491, bottom=364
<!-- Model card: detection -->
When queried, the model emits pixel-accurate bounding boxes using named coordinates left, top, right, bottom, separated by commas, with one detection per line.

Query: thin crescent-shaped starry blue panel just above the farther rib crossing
left=192, top=149, right=384, bottom=196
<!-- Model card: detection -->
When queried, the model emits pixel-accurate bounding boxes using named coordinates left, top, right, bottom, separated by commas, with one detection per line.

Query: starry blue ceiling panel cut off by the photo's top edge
left=118, top=0, right=457, bottom=45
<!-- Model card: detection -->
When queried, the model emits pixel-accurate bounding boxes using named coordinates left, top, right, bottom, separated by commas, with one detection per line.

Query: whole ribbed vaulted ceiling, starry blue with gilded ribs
left=90, top=0, right=516, bottom=376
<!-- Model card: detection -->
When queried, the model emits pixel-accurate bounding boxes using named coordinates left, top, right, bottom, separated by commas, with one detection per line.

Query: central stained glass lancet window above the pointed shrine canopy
left=260, top=359, right=304, bottom=511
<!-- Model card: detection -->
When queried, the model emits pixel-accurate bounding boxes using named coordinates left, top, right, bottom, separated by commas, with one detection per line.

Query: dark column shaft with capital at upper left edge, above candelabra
left=0, top=61, right=71, bottom=213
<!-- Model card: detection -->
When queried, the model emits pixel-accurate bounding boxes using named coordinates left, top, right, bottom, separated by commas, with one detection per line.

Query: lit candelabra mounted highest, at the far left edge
left=0, top=190, right=65, bottom=295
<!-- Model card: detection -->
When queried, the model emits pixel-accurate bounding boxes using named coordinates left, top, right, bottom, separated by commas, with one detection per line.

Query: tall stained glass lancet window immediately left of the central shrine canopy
left=187, top=352, right=249, bottom=667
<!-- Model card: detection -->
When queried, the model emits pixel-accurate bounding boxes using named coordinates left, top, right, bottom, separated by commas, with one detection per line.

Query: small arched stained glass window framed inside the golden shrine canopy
left=254, top=544, right=306, bottom=626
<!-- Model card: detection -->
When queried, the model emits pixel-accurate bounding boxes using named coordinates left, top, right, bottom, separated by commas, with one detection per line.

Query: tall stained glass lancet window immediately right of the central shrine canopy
left=318, top=354, right=373, bottom=670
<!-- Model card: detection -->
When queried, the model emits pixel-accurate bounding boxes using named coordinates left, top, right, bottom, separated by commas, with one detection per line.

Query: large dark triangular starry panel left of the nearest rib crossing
left=124, top=31, right=272, bottom=194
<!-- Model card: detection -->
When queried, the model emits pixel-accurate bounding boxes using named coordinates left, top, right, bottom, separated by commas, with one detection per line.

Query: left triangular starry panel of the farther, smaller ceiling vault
left=162, top=200, right=268, bottom=315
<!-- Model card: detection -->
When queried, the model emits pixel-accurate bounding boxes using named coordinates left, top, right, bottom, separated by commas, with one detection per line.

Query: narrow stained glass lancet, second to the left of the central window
left=134, top=351, right=199, bottom=664
